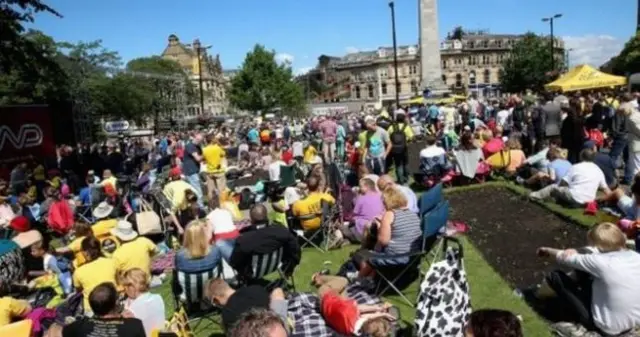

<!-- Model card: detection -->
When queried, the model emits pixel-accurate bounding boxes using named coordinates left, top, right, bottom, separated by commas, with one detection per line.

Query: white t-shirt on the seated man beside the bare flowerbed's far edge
left=562, top=162, right=607, bottom=204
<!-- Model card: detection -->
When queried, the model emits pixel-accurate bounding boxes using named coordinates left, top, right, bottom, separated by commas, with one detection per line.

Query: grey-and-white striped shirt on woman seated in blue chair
left=385, top=209, right=422, bottom=254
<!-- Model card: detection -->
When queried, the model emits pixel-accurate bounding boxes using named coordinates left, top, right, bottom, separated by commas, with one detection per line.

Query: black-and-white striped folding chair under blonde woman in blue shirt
left=171, top=264, right=222, bottom=330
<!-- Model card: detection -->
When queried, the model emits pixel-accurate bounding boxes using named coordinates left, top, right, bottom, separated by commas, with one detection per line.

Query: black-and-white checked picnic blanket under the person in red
left=288, top=282, right=382, bottom=337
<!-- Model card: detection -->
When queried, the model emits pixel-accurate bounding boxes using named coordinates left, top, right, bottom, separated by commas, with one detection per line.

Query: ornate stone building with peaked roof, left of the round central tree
left=162, top=34, right=228, bottom=117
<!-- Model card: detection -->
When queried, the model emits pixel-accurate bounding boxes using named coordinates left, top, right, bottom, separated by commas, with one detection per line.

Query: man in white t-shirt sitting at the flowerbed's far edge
left=529, top=149, right=611, bottom=207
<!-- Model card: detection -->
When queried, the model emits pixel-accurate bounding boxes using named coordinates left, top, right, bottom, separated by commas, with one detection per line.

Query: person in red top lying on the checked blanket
left=312, top=274, right=396, bottom=337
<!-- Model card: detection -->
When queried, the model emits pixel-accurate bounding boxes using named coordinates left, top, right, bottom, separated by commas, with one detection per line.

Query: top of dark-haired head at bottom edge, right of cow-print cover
left=464, top=309, right=523, bottom=337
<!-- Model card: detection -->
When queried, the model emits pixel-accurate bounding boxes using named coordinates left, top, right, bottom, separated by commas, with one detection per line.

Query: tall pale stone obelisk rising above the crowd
left=418, top=0, right=449, bottom=95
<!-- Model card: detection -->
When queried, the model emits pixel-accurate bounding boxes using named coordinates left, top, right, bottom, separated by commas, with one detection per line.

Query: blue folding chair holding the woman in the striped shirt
left=369, top=200, right=449, bottom=306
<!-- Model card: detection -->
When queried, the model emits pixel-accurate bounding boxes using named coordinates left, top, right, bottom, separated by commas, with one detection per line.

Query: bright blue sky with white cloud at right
left=33, top=0, right=637, bottom=72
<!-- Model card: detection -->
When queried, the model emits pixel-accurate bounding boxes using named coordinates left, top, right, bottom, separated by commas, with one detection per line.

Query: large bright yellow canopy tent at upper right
left=544, top=64, right=627, bottom=92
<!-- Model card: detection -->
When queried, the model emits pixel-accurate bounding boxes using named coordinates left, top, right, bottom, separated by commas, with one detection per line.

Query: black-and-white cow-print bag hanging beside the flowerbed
left=414, top=245, right=471, bottom=337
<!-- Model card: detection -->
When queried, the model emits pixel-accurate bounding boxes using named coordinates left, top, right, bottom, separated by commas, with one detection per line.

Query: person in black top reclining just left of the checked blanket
left=207, top=279, right=288, bottom=330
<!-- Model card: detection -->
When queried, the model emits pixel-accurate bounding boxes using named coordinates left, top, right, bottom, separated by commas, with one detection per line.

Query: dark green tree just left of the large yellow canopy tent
left=500, top=33, right=564, bottom=92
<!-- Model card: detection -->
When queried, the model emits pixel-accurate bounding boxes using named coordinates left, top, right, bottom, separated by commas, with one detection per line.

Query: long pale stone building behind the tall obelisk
left=309, top=33, right=564, bottom=103
